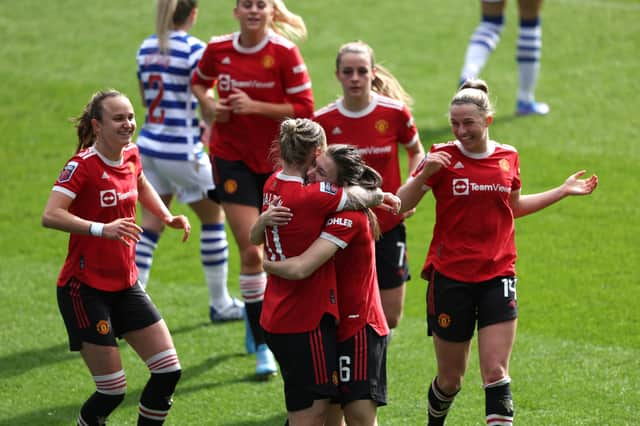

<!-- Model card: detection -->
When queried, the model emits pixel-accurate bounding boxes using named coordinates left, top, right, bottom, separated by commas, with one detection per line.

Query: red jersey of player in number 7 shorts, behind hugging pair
left=314, top=92, right=420, bottom=232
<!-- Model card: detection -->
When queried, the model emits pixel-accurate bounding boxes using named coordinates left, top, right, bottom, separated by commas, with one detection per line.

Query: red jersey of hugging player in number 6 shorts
left=321, top=211, right=389, bottom=342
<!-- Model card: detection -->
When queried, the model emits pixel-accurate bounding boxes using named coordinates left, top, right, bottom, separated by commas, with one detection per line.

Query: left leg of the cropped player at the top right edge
left=460, top=0, right=506, bottom=83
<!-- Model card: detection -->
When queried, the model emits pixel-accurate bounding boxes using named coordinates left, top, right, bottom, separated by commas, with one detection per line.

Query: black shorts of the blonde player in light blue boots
left=210, top=157, right=271, bottom=210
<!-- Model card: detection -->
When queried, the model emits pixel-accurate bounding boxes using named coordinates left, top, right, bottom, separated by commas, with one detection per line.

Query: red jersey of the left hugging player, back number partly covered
left=260, top=172, right=346, bottom=333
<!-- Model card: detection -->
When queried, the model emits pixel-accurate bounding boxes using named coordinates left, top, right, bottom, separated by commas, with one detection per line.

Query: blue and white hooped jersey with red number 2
left=136, top=31, right=205, bottom=161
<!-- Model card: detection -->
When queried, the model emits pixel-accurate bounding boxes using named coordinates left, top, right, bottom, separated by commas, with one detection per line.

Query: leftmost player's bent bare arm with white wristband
left=42, top=191, right=142, bottom=246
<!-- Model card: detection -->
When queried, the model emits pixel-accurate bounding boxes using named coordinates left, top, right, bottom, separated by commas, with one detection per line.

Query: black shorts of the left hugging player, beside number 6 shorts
left=264, top=315, right=338, bottom=411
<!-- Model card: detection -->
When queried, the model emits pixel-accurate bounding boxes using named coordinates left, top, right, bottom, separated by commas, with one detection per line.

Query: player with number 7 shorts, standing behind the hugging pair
left=314, top=41, right=424, bottom=328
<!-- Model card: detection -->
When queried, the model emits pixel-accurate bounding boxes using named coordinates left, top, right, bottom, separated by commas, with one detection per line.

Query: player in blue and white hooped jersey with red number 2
left=136, top=0, right=244, bottom=322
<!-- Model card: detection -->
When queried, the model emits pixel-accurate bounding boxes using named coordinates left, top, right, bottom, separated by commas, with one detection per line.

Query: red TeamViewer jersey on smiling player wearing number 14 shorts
left=412, top=141, right=521, bottom=282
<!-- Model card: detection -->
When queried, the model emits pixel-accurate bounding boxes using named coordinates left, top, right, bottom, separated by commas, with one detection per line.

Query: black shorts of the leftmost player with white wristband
left=58, top=278, right=162, bottom=351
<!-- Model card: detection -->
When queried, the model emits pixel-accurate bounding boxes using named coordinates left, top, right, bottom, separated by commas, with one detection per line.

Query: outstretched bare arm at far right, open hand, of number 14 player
left=509, top=170, right=598, bottom=218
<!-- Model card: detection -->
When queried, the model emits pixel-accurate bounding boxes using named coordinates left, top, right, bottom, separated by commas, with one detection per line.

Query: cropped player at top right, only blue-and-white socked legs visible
left=460, top=0, right=549, bottom=115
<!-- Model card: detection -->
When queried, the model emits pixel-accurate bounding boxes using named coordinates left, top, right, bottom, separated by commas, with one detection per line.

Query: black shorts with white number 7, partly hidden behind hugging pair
left=376, top=223, right=411, bottom=290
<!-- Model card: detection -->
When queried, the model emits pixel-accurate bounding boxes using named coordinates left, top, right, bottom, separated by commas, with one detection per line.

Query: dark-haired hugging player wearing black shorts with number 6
left=264, top=145, right=389, bottom=426
